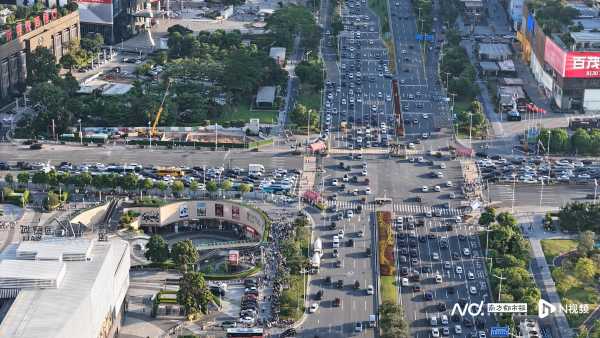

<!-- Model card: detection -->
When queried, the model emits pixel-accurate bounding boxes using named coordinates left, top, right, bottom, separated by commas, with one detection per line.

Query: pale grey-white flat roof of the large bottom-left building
left=0, top=239, right=129, bottom=338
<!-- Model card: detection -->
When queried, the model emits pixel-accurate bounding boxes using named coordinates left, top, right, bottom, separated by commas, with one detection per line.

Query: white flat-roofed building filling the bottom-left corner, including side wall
left=0, top=238, right=130, bottom=338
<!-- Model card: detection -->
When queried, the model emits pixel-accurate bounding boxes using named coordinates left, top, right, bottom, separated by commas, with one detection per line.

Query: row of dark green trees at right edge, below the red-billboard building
left=538, top=128, right=600, bottom=156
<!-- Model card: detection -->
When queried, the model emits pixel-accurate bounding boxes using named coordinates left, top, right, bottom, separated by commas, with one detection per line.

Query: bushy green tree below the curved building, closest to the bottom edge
left=177, top=272, right=213, bottom=316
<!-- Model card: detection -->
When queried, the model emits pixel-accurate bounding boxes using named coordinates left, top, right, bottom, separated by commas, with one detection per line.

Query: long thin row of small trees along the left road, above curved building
left=4, top=170, right=254, bottom=196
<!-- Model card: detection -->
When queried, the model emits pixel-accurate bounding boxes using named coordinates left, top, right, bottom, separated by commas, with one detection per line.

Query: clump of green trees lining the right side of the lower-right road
left=479, top=208, right=541, bottom=323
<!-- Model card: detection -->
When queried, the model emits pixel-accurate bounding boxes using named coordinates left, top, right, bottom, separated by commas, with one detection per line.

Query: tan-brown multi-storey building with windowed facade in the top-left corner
left=0, top=9, right=80, bottom=99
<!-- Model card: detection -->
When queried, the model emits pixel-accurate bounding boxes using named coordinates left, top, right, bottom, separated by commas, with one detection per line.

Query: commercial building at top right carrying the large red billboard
left=517, top=4, right=600, bottom=113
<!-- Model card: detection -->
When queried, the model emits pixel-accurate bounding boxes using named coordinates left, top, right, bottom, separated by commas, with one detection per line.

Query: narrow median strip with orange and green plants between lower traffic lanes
left=377, top=211, right=398, bottom=303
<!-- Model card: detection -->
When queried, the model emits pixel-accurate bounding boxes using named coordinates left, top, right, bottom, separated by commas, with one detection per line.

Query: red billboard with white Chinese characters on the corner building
left=544, top=37, right=600, bottom=78
